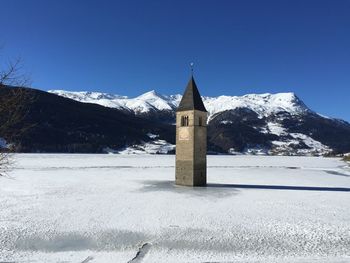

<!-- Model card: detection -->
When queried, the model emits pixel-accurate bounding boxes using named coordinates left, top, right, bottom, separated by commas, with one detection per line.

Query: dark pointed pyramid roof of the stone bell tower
left=176, top=76, right=207, bottom=112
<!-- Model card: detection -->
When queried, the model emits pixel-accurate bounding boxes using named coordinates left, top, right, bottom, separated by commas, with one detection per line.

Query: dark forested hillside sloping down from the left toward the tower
left=0, top=87, right=174, bottom=153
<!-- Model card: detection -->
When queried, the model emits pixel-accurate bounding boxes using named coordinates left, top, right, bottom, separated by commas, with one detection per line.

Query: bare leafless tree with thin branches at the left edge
left=0, top=50, right=30, bottom=176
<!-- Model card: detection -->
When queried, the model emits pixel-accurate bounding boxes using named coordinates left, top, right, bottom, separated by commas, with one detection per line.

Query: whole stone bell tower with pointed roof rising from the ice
left=175, top=76, right=207, bottom=186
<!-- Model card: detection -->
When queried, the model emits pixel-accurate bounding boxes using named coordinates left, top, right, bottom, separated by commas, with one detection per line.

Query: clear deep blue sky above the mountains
left=0, top=0, right=350, bottom=121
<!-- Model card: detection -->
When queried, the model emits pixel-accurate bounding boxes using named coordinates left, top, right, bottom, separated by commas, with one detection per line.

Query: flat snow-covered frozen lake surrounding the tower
left=0, top=154, right=350, bottom=263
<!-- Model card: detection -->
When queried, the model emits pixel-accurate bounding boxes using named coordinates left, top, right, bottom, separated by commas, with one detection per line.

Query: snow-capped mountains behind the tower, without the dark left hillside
left=49, top=90, right=350, bottom=155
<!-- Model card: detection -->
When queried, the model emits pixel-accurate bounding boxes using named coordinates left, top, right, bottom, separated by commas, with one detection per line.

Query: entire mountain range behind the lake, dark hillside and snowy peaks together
left=0, top=84, right=350, bottom=155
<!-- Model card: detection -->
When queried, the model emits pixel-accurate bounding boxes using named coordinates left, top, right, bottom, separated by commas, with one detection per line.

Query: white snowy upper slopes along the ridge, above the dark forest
left=49, top=90, right=309, bottom=117
